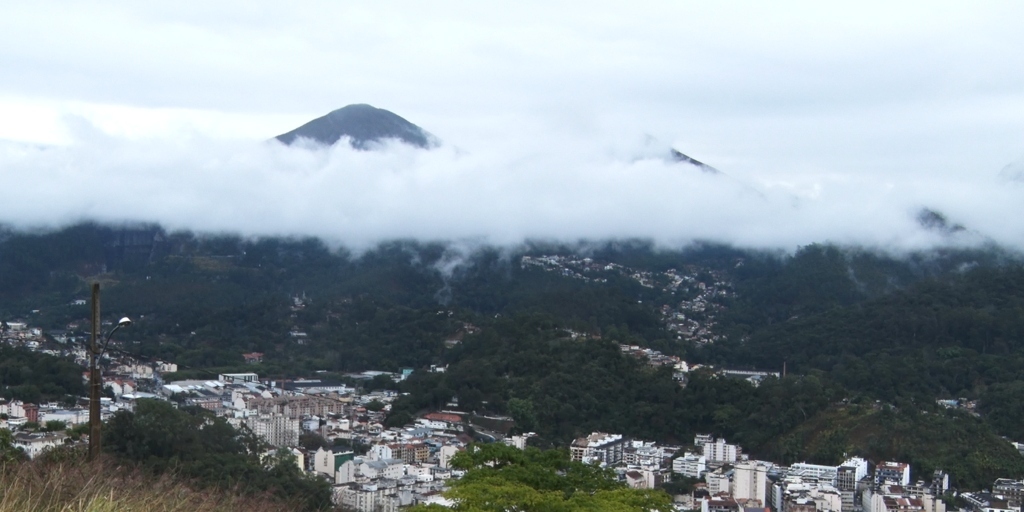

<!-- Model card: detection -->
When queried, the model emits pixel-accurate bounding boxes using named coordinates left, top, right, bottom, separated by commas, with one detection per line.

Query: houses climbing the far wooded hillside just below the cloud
left=519, top=255, right=741, bottom=344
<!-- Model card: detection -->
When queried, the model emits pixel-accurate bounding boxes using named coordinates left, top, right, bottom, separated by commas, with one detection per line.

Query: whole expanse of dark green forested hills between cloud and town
left=0, top=224, right=1024, bottom=486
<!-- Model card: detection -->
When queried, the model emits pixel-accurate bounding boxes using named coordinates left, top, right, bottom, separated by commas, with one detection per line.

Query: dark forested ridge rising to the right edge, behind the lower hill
left=714, top=263, right=1024, bottom=399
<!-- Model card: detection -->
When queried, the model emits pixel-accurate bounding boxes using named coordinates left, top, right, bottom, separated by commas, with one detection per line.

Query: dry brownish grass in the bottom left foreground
left=0, top=454, right=303, bottom=512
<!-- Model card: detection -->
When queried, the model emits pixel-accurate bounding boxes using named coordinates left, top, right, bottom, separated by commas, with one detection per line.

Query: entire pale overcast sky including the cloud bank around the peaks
left=0, top=1, right=1024, bottom=249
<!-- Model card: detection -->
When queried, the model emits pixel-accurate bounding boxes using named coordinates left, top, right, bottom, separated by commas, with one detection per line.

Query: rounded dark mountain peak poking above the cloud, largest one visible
left=274, top=103, right=439, bottom=150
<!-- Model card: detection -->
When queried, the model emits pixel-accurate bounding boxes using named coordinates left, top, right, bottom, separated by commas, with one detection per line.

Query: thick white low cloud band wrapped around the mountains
left=0, top=121, right=1024, bottom=251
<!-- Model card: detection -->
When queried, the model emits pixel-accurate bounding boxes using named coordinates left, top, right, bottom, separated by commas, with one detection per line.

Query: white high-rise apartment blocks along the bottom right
left=571, top=433, right=958, bottom=512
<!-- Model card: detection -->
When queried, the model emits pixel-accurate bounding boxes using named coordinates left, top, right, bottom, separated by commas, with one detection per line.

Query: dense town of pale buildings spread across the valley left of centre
left=0, top=315, right=468, bottom=511
